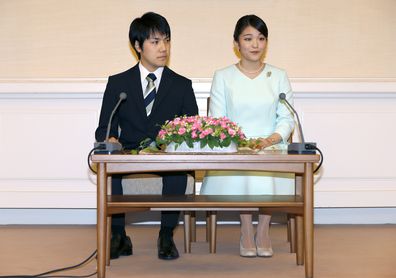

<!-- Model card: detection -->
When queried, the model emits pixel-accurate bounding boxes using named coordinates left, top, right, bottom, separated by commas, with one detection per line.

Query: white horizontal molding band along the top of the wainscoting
left=0, top=78, right=396, bottom=99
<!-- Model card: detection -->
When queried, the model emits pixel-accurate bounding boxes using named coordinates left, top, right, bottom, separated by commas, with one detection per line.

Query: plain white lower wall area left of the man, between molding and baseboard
left=0, top=96, right=101, bottom=208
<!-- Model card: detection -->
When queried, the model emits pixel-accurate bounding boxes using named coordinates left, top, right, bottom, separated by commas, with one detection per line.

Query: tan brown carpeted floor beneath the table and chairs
left=0, top=225, right=396, bottom=278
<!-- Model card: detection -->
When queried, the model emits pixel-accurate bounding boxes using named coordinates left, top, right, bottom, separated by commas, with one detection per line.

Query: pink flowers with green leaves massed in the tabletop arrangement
left=156, top=116, right=245, bottom=149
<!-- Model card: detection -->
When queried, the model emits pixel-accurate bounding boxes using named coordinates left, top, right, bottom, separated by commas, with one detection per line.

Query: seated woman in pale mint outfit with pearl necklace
left=201, top=15, right=294, bottom=257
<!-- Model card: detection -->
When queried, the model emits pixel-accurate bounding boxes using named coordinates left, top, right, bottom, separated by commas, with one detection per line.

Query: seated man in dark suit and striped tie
left=95, top=12, right=198, bottom=260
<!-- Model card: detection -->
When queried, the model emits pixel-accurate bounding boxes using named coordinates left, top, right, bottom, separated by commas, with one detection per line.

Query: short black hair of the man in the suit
left=129, top=12, right=170, bottom=59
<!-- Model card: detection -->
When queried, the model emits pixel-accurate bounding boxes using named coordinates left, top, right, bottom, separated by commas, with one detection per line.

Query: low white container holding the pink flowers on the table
left=165, top=142, right=238, bottom=153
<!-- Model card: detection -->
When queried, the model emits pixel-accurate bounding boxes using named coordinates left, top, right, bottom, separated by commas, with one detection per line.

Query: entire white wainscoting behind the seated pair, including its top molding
left=0, top=79, right=396, bottom=213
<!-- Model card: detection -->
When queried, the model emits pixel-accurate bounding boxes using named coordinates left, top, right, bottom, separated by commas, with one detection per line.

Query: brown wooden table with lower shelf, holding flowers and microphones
left=92, top=151, right=319, bottom=278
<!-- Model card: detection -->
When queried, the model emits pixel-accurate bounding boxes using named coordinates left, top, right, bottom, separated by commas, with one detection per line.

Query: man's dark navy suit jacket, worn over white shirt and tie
left=95, top=64, right=198, bottom=149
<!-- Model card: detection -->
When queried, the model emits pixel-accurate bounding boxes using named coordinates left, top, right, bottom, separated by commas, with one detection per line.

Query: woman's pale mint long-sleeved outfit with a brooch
left=201, top=64, right=294, bottom=195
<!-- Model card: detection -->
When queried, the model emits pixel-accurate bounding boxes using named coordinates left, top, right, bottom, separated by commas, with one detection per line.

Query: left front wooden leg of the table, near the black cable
left=96, top=163, right=107, bottom=278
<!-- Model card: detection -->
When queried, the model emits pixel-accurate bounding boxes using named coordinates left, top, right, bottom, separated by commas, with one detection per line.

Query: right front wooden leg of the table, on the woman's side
left=304, top=163, right=314, bottom=278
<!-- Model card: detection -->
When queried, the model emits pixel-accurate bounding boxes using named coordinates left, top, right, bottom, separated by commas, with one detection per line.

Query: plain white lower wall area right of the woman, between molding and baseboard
left=296, top=95, right=396, bottom=207
